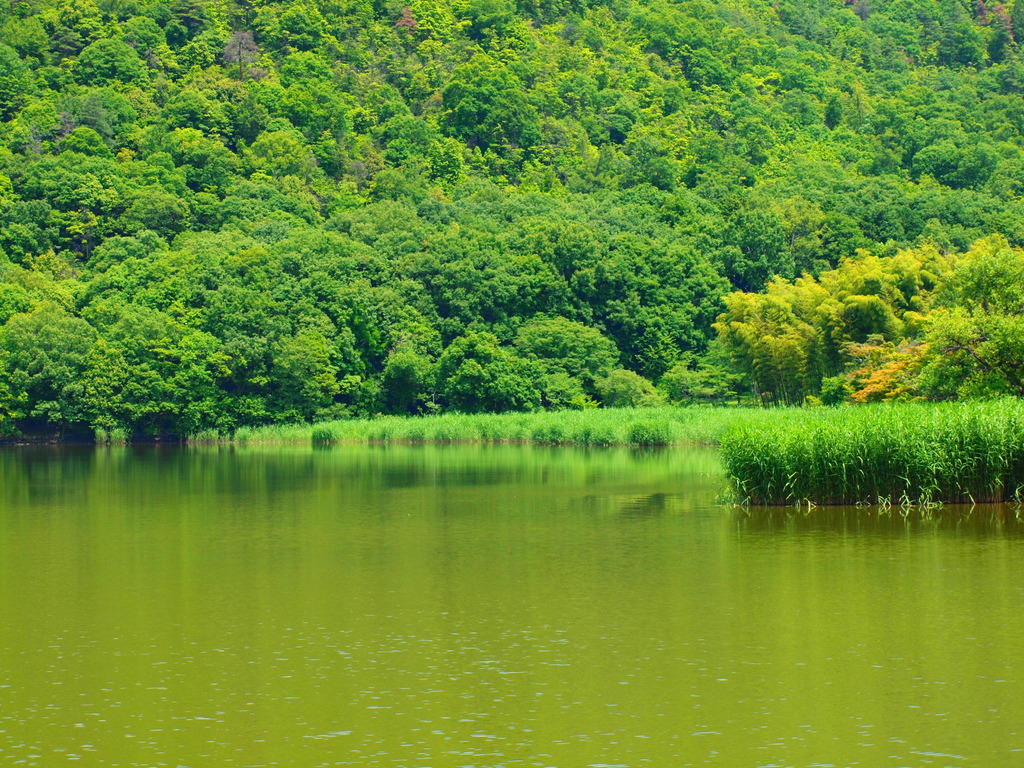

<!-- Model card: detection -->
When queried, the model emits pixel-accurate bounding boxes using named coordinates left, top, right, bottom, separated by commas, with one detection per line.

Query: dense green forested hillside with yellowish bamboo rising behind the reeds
left=0, top=0, right=1024, bottom=435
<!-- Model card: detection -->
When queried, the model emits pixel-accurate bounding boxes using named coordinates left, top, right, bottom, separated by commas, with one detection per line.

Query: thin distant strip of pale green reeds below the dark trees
left=229, top=408, right=759, bottom=445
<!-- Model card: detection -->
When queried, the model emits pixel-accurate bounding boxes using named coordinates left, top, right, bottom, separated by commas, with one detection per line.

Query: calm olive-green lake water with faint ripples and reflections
left=0, top=446, right=1024, bottom=768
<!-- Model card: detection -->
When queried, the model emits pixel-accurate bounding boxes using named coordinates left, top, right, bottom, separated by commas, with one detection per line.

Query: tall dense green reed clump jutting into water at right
left=721, top=398, right=1024, bottom=507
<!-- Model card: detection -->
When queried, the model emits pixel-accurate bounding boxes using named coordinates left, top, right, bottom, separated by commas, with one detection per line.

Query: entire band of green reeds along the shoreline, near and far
left=190, top=398, right=1024, bottom=507
